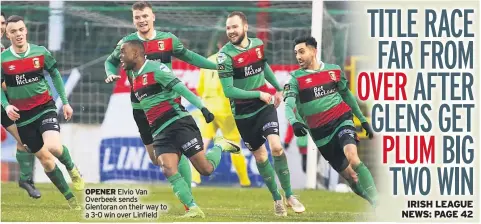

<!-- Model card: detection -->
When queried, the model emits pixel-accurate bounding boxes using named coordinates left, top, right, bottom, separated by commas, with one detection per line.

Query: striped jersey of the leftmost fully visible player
left=1, top=44, right=57, bottom=126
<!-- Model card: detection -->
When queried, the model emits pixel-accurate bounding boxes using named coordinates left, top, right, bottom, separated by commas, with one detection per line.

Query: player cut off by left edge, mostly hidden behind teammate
left=0, top=12, right=41, bottom=198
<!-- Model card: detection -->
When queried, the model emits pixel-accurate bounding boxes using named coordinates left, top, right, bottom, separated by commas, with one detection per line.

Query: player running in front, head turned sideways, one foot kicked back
left=120, top=40, right=240, bottom=218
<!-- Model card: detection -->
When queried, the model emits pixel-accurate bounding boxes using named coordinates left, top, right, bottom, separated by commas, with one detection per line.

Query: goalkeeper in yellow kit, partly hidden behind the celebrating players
left=192, top=39, right=251, bottom=187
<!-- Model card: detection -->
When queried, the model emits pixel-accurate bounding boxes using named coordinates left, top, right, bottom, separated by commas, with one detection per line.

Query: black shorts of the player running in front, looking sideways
left=154, top=116, right=204, bottom=158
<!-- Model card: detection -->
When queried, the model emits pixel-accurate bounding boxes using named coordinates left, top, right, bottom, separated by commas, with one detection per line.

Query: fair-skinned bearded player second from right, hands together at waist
left=217, top=12, right=305, bottom=216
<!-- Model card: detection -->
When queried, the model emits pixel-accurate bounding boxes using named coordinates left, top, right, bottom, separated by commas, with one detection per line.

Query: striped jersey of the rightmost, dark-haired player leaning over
left=284, top=64, right=354, bottom=147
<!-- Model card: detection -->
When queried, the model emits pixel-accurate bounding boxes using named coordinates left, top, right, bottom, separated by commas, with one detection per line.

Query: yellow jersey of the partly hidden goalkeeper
left=197, top=54, right=232, bottom=115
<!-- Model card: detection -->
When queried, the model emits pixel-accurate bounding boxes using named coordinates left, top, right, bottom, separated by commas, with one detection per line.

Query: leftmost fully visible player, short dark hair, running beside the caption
left=1, top=15, right=85, bottom=210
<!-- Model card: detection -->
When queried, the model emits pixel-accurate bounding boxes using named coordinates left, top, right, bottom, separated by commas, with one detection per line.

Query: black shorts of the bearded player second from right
left=235, top=105, right=279, bottom=151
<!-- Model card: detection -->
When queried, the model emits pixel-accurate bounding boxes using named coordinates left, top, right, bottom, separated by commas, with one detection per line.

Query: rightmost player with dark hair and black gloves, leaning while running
left=284, top=37, right=377, bottom=207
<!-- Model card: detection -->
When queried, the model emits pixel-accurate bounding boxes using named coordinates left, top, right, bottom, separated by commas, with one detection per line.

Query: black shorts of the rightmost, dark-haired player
left=319, top=126, right=359, bottom=172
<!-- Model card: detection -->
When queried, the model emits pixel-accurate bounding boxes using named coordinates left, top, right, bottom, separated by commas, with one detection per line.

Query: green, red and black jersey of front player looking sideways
left=127, top=60, right=190, bottom=136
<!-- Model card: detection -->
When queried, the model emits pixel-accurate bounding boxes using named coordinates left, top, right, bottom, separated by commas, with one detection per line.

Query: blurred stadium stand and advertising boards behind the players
left=1, top=1, right=376, bottom=191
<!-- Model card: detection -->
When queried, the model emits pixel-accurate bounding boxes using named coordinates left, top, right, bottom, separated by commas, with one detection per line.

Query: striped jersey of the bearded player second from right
left=217, top=38, right=268, bottom=119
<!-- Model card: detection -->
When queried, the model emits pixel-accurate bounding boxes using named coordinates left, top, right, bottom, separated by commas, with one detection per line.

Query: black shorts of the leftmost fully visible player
left=17, top=111, right=60, bottom=153
